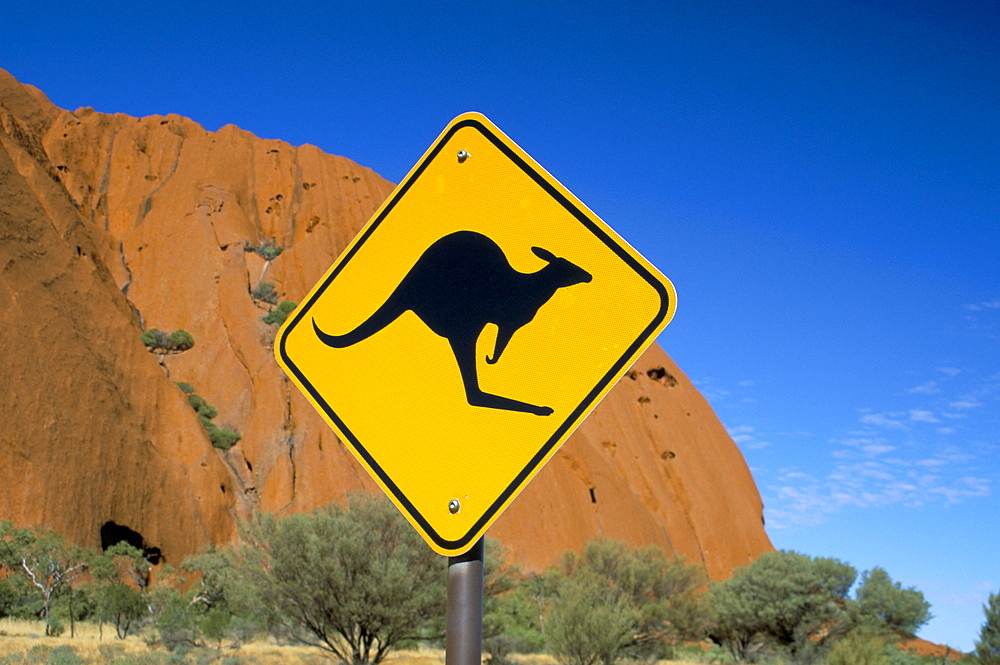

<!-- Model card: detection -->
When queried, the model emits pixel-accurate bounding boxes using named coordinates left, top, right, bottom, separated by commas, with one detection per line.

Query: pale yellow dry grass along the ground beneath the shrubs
left=0, top=619, right=698, bottom=665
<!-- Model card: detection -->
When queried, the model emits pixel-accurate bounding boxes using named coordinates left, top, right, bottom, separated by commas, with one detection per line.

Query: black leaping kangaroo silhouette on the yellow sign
left=313, top=231, right=592, bottom=416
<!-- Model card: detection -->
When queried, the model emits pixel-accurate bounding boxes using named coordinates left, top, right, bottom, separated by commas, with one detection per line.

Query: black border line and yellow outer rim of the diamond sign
left=277, top=113, right=676, bottom=556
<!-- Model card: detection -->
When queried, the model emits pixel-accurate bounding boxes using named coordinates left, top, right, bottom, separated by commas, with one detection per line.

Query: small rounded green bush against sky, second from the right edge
left=855, top=567, right=931, bottom=636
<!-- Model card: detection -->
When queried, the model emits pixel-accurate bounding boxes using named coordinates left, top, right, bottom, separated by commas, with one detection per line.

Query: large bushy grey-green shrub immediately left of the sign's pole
left=234, top=495, right=445, bottom=665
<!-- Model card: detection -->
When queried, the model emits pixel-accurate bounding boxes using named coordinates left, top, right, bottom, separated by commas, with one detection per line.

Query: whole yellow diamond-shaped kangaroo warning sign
left=275, top=113, right=676, bottom=556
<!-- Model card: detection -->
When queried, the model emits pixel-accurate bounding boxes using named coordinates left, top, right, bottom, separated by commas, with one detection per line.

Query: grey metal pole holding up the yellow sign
left=444, top=538, right=483, bottom=665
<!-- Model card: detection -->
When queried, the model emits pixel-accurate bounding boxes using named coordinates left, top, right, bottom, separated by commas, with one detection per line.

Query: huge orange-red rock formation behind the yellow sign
left=0, top=70, right=771, bottom=578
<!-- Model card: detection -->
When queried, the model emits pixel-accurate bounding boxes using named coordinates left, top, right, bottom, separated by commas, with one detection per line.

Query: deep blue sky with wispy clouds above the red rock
left=0, top=0, right=1000, bottom=650
